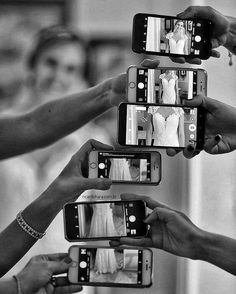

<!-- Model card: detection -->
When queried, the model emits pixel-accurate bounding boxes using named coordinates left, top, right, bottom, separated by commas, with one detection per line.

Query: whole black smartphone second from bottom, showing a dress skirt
left=63, top=200, right=148, bottom=241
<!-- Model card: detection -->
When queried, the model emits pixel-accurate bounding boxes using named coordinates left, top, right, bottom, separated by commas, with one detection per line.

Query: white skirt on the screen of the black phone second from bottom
left=89, top=203, right=118, bottom=237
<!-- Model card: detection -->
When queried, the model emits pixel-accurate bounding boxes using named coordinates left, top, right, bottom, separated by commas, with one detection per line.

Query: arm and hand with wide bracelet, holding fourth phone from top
left=0, top=140, right=112, bottom=276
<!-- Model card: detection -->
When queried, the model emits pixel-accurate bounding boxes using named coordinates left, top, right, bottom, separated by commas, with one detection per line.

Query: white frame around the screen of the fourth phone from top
left=88, top=150, right=162, bottom=186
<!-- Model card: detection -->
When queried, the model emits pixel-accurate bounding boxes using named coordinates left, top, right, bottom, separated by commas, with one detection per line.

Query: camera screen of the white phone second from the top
left=136, top=69, right=198, bottom=104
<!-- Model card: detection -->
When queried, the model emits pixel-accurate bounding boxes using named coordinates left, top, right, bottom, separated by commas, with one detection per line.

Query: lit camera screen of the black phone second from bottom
left=74, top=201, right=147, bottom=238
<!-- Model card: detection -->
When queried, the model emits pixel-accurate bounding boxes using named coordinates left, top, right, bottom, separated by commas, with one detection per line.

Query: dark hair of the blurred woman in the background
left=28, top=25, right=85, bottom=69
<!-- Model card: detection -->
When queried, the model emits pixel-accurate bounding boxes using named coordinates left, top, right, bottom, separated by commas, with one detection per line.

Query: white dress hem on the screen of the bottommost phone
left=94, top=248, right=118, bottom=274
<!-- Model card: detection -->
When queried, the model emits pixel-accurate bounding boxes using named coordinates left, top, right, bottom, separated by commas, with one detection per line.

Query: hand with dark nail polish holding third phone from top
left=167, top=96, right=236, bottom=158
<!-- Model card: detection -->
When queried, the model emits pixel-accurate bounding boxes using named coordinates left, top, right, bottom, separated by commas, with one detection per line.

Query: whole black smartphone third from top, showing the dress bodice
left=118, top=103, right=205, bottom=150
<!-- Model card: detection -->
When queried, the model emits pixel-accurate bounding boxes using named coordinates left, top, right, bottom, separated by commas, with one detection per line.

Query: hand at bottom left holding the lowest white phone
left=16, top=253, right=82, bottom=294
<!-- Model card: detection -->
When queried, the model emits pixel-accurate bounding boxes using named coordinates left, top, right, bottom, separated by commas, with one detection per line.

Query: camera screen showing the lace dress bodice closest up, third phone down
left=125, top=104, right=197, bottom=147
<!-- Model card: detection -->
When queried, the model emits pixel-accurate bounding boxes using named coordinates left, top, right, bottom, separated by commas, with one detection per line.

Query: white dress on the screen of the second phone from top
left=160, top=74, right=178, bottom=104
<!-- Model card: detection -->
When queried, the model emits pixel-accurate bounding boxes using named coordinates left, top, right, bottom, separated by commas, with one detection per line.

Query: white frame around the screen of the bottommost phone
left=68, top=245, right=154, bottom=288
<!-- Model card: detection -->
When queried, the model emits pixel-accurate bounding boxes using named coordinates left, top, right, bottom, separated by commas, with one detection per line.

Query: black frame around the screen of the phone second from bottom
left=63, top=200, right=148, bottom=242
